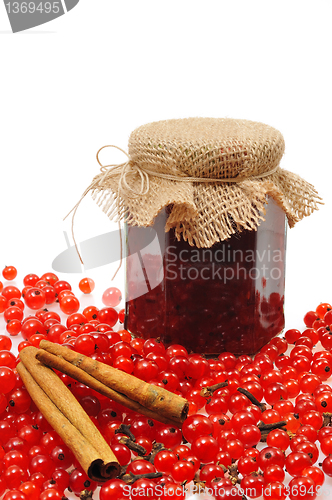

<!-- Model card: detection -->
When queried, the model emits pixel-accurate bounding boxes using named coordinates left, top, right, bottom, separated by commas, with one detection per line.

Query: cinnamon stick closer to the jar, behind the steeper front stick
left=36, top=340, right=189, bottom=425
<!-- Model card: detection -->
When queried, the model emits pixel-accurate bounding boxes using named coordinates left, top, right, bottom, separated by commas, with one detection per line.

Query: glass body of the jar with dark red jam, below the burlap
left=125, top=198, right=286, bottom=355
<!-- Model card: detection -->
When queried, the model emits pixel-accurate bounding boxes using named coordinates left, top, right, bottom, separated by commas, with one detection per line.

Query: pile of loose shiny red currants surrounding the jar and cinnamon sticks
left=0, top=267, right=332, bottom=500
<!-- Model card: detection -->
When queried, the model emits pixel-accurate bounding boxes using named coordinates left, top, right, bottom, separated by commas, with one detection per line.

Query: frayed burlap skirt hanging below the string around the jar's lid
left=92, top=168, right=321, bottom=248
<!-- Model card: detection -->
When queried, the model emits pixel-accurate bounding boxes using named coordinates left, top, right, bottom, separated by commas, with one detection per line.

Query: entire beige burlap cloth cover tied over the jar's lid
left=84, top=118, right=320, bottom=248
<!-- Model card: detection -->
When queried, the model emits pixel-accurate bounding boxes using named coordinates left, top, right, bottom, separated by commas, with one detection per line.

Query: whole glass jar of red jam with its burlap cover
left=87, top=118, right=319, bottom=355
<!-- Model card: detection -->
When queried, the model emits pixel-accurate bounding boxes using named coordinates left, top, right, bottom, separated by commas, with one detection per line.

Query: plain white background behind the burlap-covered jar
left=0, top=0, right=332, bottom=496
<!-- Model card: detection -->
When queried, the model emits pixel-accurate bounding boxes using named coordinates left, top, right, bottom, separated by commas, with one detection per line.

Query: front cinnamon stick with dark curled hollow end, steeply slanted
left=17, top=346, right=120, bottom=482
